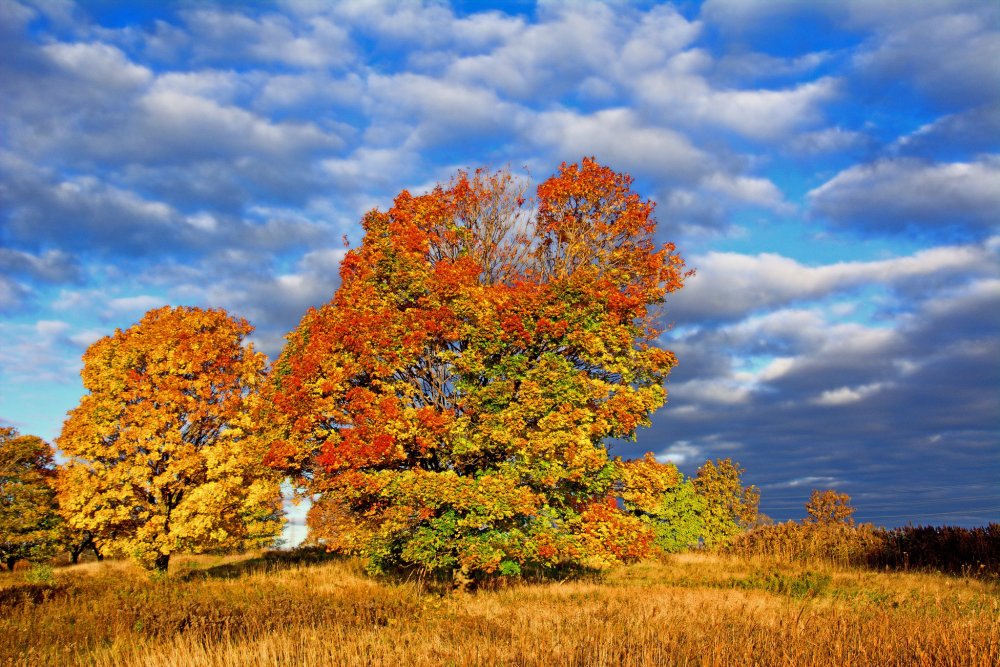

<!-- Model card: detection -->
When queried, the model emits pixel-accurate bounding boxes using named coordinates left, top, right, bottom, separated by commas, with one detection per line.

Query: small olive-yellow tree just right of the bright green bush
left=694, top=458, right=760, bottom=547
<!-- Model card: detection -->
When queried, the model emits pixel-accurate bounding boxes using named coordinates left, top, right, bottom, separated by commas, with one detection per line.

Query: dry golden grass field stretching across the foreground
left=0, top=554, right=1000, bottom=667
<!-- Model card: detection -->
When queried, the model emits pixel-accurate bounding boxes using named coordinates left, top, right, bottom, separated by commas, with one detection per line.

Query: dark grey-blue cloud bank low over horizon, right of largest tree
left=626, top=260, right=1000, bottom=525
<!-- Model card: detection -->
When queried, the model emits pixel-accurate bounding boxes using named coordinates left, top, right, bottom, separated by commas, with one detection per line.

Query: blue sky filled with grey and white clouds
left=0, top=0, right=1000, bottom=541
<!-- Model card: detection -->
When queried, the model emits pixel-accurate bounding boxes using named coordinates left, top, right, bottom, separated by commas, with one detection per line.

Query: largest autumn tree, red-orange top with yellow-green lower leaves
left=262, top=159, right=685, bottom=577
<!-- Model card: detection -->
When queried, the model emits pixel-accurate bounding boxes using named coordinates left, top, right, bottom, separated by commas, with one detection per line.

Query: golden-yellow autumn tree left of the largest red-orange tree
left=58, top=307, right=281, bottom=570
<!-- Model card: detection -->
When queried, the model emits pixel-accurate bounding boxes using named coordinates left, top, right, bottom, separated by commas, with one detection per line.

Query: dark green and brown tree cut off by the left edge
left=0, top=426, right=59, bottom=570
